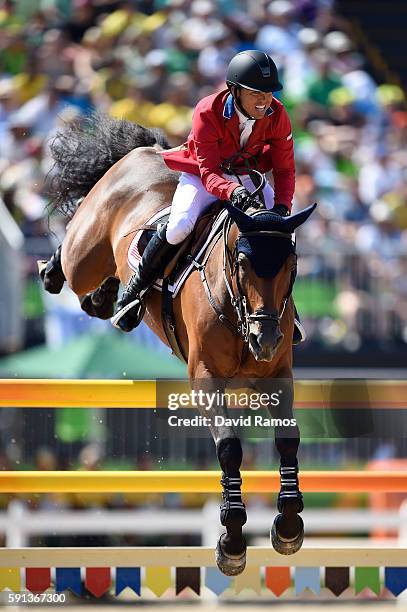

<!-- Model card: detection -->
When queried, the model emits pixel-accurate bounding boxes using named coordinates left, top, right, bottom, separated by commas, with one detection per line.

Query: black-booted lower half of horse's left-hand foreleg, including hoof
left=216, top=438, right=247, bottom=576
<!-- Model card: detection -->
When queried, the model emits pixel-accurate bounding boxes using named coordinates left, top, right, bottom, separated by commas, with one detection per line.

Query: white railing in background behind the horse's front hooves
left=0, top=500, right=407, bottom=547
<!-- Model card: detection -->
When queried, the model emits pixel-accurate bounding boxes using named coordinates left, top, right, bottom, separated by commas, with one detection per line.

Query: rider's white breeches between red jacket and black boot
left=166, top=172, right=274, bottom=244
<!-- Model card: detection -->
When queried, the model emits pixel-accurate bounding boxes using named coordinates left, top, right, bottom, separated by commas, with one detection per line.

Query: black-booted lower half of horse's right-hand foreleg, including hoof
left=270, top=436, right=304, bottom=555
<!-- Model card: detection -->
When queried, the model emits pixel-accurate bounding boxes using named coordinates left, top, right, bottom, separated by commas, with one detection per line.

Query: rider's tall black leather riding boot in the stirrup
left=112, top=224, right=180, bottom=332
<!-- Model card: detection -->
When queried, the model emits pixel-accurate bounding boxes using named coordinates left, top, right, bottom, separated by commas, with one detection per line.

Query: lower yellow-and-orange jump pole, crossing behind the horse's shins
left=0, top=470, right=407, bottom=493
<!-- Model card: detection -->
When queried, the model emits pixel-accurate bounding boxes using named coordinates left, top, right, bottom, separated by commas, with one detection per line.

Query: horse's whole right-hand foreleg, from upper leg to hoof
left=256, top=377, right=304, bottom=555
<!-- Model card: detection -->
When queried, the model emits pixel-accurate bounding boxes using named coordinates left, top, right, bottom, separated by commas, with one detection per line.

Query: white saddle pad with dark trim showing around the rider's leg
left=127, top=206, right=228, bottom=297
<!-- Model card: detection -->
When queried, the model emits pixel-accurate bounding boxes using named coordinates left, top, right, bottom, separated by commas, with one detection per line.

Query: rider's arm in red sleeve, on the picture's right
left=259, top=105, right=295, bottom=210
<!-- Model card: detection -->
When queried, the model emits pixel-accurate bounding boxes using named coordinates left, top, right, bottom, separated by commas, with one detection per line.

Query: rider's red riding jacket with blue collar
left=161, top=90, right=295, bottom=209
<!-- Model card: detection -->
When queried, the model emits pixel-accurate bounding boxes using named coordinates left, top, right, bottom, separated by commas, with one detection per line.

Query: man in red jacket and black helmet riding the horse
left=113, top=51, right=304, bottom=344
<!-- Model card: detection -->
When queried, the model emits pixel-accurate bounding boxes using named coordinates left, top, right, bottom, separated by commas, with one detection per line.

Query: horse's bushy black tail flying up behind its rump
left=48, top=112, right=169, bottom=217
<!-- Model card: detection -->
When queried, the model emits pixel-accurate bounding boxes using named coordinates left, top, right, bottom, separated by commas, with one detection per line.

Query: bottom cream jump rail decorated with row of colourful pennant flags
left=0, top=546, right=407, bottom=598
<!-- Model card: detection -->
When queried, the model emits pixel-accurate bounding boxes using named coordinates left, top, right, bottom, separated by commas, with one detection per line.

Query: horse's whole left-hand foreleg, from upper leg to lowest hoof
left=192, top=372, right=247, bottom=576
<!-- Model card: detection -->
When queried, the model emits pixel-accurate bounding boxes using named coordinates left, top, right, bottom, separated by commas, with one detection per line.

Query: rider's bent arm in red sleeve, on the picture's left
left=192, top=105, right=240, bottom=200
